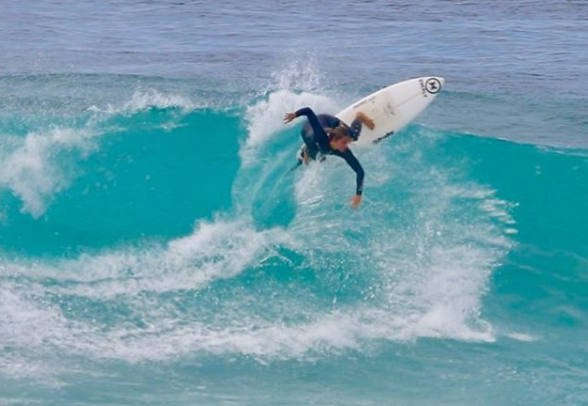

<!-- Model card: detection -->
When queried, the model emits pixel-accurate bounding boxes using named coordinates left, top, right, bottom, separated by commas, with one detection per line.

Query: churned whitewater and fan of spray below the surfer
left=2, top=131, right=510, bottom=372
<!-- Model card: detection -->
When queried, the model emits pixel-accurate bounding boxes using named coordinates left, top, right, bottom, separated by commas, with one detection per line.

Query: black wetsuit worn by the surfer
left=296, top=107, right=364, bottom=195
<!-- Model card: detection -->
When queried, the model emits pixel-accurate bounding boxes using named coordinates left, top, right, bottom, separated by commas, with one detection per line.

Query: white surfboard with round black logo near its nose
left=297, top=76, right=445, bottom=157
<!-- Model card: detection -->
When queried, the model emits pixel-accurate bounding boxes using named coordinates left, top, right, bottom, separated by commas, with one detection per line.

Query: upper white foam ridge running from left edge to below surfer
left=10, top=220, right=288, bottom=298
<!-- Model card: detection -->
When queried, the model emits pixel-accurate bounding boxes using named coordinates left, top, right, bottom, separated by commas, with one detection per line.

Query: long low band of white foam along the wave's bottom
left=0, top=282, right=490, bottom=364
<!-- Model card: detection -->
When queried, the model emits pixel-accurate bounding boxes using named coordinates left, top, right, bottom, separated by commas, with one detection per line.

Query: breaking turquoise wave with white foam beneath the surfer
left=0, top=78, right=586, bottom=384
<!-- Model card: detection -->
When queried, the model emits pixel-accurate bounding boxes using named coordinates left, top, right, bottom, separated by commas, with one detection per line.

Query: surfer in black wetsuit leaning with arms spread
left=284, top=107, right=374, bottom=207
